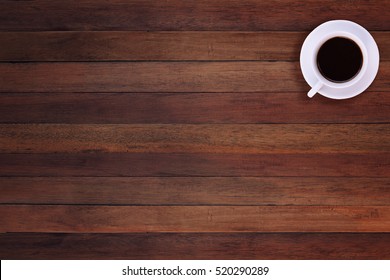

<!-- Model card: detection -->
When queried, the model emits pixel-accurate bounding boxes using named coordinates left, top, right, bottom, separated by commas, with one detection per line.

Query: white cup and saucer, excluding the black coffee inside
left=300, top=20, right=379, bottom=99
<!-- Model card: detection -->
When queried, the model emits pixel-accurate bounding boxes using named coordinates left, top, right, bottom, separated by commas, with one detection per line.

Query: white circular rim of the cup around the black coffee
left=311, top=31, right=368, bottom=88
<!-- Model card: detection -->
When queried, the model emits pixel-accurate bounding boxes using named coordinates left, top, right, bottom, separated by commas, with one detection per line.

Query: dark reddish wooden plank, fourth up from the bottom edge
left=0, top=153, right=390, bottom=177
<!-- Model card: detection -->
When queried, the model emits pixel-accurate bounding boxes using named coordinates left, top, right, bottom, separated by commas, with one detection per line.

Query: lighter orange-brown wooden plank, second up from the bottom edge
left=0, top=205, right=390, bottom=233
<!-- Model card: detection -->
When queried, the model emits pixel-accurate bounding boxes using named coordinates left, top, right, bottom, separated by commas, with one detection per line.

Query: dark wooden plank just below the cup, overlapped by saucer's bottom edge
left=0, top=92, right=390, bottom=124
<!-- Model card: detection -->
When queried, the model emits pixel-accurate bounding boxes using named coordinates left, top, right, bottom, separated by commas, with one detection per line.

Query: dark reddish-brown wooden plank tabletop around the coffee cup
left=0, top=0, right=390, bottom=259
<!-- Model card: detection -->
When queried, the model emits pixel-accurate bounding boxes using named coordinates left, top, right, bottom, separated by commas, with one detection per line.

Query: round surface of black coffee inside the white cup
left=317, top=37, right=363, bottom=83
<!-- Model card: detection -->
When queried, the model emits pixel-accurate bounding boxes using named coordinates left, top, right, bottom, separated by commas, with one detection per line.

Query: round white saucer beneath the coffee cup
left=300, top=20, right=379, bottom=99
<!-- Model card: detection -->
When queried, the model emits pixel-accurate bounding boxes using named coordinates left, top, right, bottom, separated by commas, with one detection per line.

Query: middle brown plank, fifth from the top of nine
left=0, top=124, right=390, bottom=154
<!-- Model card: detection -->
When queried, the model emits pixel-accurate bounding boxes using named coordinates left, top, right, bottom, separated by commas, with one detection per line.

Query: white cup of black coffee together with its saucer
left=300, top=20, right=379, bottom=99
